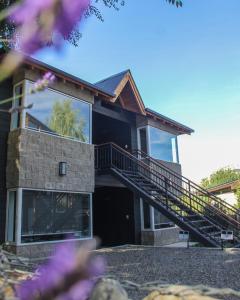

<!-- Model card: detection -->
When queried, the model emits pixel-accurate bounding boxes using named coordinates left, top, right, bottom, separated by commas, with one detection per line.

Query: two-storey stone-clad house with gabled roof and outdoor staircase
left=0, top=58, right=240, bottom=256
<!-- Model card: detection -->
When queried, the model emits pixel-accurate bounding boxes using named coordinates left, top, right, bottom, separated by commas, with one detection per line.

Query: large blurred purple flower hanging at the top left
left=10, top=0, right=90, bottom=54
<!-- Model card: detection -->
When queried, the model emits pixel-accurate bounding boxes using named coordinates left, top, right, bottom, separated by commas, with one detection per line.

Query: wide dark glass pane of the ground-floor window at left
left=21, top=190, right=91, bottom=243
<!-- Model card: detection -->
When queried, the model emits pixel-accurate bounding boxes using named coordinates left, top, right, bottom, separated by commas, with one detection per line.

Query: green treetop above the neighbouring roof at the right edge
left=201, top=167, right=240, bottom=188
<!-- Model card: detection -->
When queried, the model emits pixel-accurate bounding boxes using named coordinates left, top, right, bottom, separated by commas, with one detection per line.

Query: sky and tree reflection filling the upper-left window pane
left=25, top=81, right=90, bottom=143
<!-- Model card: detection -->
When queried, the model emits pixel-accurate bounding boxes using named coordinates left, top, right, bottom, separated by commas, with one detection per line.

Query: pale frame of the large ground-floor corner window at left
left=5, top=188, right=93, bottom=246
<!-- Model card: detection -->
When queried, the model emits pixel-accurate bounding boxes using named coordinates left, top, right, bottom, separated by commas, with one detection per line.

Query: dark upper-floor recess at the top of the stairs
left=92, top=112, right=131, bottom=150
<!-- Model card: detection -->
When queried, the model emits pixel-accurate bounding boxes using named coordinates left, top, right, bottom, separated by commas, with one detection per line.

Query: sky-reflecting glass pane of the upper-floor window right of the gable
left=149, top=126, right=178, bottom=163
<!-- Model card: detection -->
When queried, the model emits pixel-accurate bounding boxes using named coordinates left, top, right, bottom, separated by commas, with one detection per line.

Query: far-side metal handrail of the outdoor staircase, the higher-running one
left=132, top=149, right=240, bottom=218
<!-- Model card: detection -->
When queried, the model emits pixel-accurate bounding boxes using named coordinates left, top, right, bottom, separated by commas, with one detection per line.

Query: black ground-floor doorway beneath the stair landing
left=93, top=187, right=135, bottom=246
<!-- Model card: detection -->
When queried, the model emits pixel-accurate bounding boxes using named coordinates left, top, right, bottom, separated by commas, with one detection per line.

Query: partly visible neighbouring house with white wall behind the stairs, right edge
left=208, top=180, right=240, bottom=205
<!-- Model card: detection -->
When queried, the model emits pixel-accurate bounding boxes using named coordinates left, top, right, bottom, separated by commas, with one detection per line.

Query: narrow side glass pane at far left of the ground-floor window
left=6, top=191, right=17, bottom=242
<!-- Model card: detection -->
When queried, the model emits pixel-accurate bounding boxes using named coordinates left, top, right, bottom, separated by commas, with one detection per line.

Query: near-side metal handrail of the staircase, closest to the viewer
left=96, top=143, right=240, bottom=230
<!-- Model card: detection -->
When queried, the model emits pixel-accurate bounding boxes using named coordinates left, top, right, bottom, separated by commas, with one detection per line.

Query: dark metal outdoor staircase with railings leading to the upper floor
left=95, top=143, right=240, bottom=247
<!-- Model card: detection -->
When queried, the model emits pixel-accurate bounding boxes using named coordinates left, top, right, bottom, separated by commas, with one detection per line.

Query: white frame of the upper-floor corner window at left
left=11, top=79, right=93, bottom=145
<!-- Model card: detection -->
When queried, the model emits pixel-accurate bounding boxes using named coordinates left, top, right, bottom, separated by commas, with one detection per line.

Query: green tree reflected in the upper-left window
left=47, top=100, right=86, bottom=142
